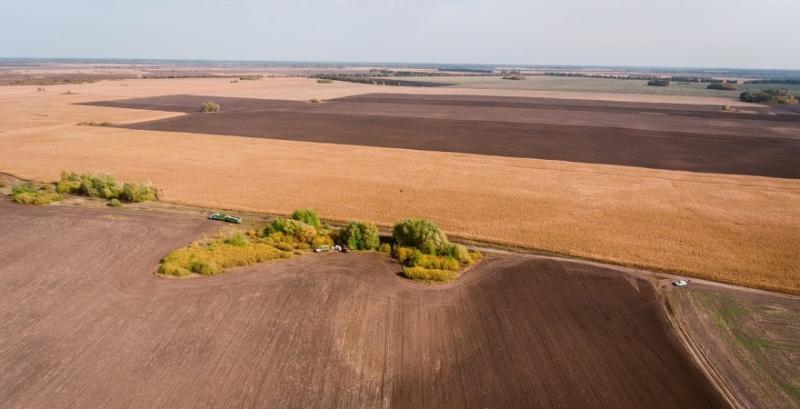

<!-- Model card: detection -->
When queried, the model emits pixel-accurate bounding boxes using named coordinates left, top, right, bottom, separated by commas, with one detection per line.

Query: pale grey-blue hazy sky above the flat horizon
left=0, top=0, right=800, bottom=69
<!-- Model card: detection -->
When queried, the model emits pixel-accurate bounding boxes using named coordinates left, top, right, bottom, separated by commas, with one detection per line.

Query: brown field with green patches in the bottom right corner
left=669, top=284, right=800, bottom=409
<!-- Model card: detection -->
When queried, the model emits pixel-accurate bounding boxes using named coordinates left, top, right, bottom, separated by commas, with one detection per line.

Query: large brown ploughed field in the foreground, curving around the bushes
left=0, top=200, right=725, bottom=409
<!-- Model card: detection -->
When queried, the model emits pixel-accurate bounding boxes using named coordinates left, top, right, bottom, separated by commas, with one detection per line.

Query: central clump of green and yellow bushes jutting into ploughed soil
left=156, top=209, right=482, bottom=283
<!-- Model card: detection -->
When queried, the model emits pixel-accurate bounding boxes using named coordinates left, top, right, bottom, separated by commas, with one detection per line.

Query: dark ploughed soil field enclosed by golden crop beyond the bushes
left=93, top=94, right=800, bottom=178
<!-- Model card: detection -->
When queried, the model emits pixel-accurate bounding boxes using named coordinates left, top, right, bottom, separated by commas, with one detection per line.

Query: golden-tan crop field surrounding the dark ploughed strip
left=0, top=78, right=800, bottom=293
